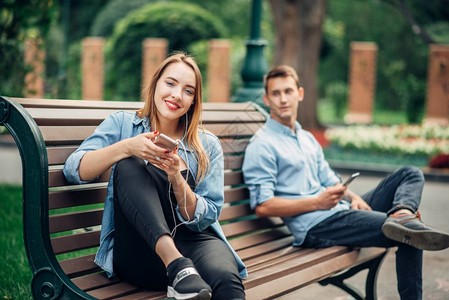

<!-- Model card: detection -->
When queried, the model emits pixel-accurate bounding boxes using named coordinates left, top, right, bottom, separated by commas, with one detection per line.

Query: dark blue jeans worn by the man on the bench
left=302, top=167, right=424, bottom=300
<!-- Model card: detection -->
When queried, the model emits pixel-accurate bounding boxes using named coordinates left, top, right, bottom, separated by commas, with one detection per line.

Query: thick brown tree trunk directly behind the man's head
left=270, top=0, right=327, bottom=128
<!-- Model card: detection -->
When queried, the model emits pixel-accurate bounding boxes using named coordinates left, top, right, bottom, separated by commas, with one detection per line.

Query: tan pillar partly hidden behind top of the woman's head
left=142, top=38, right=168, bottom=86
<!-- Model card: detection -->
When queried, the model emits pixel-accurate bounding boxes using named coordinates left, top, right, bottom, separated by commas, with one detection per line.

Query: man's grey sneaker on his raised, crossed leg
left=382, top=212, right=449, bottom=250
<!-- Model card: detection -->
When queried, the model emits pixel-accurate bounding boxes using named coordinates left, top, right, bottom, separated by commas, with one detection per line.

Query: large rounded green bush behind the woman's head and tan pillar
left=106, top=2, right=226, bottom=100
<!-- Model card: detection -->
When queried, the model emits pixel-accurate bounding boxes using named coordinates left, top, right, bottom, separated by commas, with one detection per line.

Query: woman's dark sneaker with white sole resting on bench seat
left=167, top=258, right=212, bottom=300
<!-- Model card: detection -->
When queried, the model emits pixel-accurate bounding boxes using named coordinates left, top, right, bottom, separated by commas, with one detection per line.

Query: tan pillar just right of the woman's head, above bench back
left=207, top=39, right=231, bottom=102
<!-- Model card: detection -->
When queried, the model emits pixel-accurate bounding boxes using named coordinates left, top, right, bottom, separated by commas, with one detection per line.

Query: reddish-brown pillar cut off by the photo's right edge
left=424, top=44, right=449, bottom=126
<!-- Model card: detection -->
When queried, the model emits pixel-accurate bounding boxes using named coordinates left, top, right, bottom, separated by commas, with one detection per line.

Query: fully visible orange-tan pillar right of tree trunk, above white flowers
left=345, top=42, right=378, bottom=124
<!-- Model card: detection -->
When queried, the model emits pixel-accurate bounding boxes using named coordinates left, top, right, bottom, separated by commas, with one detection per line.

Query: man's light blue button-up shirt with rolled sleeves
left=243, top=118, right=350, bottom=246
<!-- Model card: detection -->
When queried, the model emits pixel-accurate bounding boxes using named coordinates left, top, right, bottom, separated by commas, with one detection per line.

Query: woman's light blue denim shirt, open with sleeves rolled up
left=63, top=111, right=247, bottom=278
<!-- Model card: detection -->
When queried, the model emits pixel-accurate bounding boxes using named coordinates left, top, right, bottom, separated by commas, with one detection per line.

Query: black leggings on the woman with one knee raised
left=113, top=157, right=245, bottom=299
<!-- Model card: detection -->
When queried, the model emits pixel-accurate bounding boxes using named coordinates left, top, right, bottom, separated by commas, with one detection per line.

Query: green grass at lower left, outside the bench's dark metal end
left=0, top=185, right=32, bottom=300
